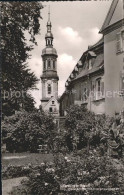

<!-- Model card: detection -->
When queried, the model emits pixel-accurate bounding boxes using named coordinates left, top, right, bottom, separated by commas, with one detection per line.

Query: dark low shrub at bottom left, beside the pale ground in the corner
left=11, top=165, right=60, bottom=195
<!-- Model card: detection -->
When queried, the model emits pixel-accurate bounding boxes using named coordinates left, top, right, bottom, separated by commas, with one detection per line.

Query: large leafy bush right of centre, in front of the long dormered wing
left=65, top=105, right=114, bottom=149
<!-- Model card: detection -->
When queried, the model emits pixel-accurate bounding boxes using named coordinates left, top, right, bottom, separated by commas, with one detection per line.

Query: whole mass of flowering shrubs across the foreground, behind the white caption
left=6, top=153, right=124, bottom=195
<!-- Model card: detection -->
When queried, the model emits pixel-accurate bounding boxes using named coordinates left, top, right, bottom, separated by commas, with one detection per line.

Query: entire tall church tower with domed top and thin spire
left=41, top=7, right=59, bottom=116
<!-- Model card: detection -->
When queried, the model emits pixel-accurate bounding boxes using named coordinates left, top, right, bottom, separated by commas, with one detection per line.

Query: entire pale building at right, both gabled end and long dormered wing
left=60, top=0, right=124, bottom=116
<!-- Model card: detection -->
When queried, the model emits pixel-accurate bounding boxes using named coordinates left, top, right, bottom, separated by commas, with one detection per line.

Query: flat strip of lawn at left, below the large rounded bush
left=2, top=153, right=53, bottom=166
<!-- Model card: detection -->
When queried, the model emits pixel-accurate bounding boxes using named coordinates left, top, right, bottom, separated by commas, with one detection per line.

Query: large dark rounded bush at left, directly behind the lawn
left=2, top=111, right=55, bottom=152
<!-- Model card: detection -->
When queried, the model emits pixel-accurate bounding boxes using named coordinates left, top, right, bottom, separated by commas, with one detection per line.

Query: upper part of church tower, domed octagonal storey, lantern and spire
left=41, top=8, right=59, bottom=80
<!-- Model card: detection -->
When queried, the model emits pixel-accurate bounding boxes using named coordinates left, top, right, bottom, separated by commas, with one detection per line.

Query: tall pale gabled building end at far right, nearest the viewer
left=100, top=0, right=124, bottom=116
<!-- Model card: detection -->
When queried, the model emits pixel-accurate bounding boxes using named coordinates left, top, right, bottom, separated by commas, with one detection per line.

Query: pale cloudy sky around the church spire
left=26, top=0, right=112, bottom=107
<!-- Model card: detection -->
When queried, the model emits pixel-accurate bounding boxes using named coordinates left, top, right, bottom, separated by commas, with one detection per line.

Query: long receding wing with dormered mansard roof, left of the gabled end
left=60, top=38, right=105, bottom=115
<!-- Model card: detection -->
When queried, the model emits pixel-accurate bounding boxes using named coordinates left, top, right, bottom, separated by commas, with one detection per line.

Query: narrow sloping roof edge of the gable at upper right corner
left=100, top=0, right=120, bottom=32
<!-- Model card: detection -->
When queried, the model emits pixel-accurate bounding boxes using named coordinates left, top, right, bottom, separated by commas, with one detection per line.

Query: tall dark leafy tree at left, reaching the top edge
left=0, top=2, right=43, bottom=115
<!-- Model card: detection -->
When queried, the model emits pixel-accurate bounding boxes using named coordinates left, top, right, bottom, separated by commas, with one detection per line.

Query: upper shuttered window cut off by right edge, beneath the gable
left=116, top=30, right=124, bottom=53
